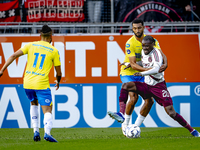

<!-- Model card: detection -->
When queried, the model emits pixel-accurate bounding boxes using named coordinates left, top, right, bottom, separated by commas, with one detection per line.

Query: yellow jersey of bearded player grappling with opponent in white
left=120, top=35, right=160, bottom=76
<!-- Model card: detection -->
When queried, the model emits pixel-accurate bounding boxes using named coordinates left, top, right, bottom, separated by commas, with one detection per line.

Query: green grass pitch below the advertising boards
left=0, top=127, right=200, bottom=150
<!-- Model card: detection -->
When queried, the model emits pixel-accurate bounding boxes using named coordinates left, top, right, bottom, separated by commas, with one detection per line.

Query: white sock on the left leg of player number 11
left=30, top=105, right=39, bottom=132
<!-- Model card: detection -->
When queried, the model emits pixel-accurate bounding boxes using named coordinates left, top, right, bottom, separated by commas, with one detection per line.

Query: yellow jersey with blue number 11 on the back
left=20, top=41, right=61, bottom=90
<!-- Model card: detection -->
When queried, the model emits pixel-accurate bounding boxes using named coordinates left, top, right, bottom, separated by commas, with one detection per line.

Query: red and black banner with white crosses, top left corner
left=0, top=0, right=21, bottom=22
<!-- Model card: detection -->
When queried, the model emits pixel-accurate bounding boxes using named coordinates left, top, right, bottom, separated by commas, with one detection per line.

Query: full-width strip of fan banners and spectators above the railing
left=0, top=0, right=200, bottom=33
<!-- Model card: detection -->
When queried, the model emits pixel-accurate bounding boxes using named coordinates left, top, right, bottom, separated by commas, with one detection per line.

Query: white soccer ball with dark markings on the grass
left=125, top=124, right=141, bottom=138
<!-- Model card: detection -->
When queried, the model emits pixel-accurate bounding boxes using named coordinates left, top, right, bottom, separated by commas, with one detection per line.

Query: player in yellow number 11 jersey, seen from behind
left=0, top=25, right=62, bottom=142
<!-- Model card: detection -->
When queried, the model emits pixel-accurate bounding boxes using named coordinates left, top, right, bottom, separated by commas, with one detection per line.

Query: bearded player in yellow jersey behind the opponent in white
left=108, top=19, right=167, bottom=133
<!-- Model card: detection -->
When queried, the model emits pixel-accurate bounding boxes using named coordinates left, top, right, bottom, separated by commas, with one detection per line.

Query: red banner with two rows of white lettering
left=25, top=0, right=85, bottom=22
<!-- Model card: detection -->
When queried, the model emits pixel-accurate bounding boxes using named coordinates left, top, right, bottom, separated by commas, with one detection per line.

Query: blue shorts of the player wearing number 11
left=25, top=88, right=52, bottom=106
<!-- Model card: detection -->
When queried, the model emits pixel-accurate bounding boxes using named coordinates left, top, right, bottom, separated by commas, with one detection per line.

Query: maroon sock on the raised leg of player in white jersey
left=119, top=89, right=128, bottom=114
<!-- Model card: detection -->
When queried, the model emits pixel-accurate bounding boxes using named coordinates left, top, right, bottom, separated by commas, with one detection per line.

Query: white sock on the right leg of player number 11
left=44, top=112, right=53, bottom=135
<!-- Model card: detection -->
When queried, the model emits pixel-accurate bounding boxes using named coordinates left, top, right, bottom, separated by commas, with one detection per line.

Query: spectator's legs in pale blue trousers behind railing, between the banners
left=87, top=0, right=104, bottom=33
